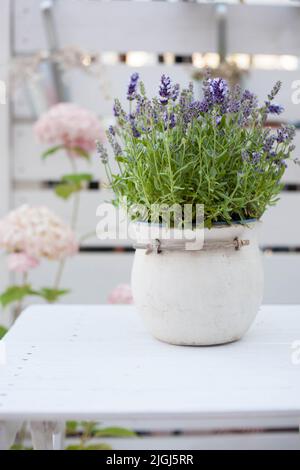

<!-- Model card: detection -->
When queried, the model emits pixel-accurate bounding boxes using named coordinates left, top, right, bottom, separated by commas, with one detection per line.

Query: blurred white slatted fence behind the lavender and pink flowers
left=0, top=0, right=300, bottom=324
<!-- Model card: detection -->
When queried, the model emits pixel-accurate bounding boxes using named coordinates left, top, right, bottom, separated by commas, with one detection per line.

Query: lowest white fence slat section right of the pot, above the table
left=263, top=253, right=300, bottom=304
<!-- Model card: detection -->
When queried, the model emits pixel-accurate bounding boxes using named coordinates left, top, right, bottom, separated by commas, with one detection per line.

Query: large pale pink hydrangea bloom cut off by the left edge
left=0, top=205, right=78, bottom=260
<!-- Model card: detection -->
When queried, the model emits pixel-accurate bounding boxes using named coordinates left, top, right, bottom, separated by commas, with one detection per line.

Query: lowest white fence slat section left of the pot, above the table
left=25, top=253, right=133, bottom=304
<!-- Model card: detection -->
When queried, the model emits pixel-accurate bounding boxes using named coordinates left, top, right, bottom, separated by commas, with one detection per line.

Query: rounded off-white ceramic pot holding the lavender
left=132, top=222, right=263, bottom=346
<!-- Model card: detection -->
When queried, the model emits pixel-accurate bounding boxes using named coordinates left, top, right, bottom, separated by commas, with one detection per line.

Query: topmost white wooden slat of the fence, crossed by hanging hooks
left=14, top=0, right=300, bottom=55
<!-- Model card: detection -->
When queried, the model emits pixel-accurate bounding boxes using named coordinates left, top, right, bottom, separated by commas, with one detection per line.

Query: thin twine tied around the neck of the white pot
left=134, top=237, right=250, bottom=255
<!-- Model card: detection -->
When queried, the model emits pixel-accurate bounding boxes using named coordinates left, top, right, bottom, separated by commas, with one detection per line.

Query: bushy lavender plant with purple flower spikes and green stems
left=98, top=73, right=295, bottom=227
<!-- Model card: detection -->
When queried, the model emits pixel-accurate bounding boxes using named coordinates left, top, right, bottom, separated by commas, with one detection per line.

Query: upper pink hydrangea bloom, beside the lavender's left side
left=34, top=103, right=104, bottom=152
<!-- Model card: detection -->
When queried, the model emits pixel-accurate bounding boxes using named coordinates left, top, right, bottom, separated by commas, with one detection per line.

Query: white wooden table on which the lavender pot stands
left=0, top=306, right=300, bottom=449
